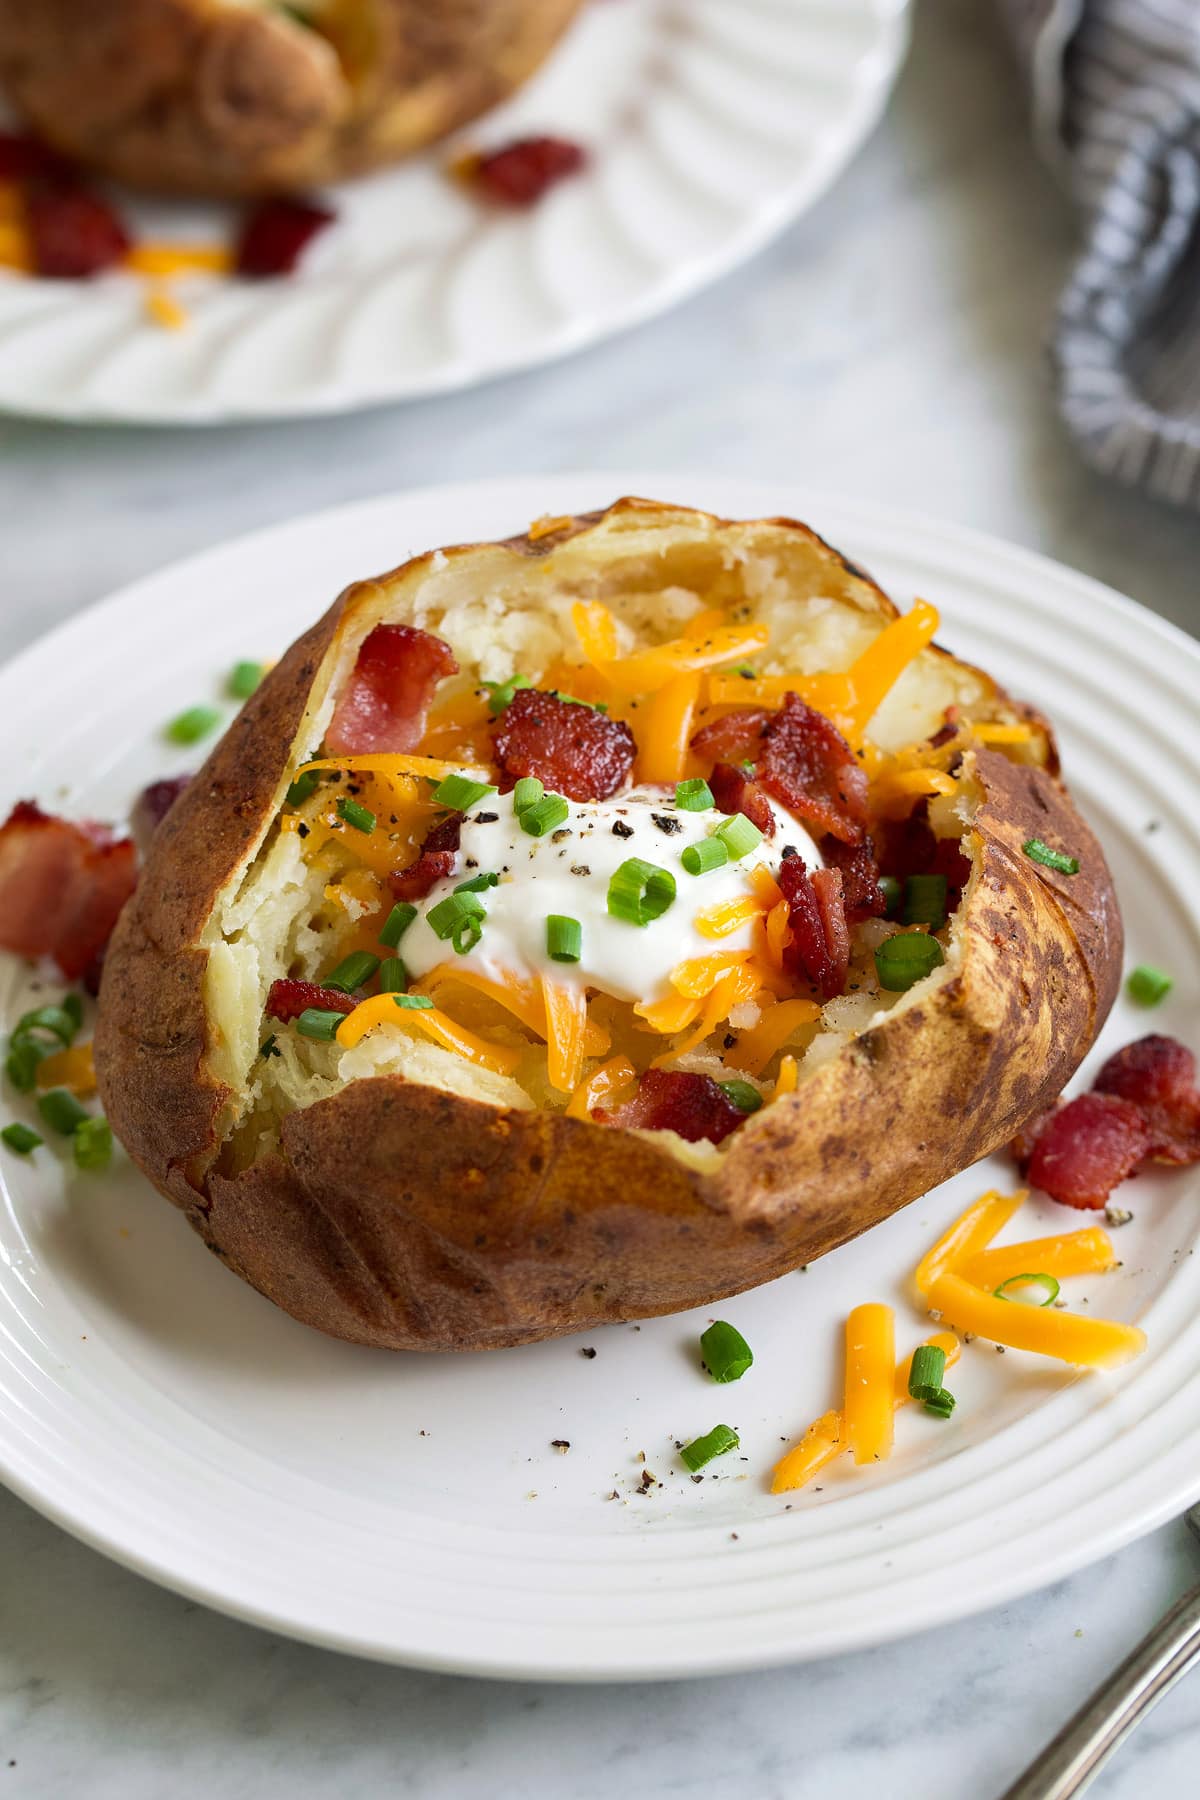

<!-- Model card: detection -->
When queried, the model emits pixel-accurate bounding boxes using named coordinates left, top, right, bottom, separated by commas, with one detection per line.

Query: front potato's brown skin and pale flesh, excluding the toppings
left=95, top=500, right=1123, bottom=1350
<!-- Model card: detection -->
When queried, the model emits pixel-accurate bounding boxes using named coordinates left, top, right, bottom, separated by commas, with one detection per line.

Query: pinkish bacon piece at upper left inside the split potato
left=326, top=625, right=459, bottom=756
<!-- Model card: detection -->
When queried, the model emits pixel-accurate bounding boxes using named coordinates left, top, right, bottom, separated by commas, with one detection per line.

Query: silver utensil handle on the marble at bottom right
left=1000, top=1588, right=1200, bottom=1800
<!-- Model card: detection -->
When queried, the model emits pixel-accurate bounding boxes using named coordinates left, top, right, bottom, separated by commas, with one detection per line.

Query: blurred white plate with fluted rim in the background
left=0, top=0, right=909, bottom=425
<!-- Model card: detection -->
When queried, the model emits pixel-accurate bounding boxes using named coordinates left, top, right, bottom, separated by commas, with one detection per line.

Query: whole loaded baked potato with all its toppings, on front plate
left=95, top=499, right=1121, bottom=1350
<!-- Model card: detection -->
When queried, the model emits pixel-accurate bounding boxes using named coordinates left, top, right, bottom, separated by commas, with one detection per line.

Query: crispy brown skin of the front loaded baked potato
left=95, top=500, right=1123, bottom=1350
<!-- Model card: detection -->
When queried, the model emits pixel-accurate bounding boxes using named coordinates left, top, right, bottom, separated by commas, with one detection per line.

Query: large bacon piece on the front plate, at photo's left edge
left=0, top=799, right=137, bottom=981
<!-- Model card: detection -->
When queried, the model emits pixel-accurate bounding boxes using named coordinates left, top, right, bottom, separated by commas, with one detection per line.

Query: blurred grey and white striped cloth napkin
left=1000, top=0, right=1200, bottom=506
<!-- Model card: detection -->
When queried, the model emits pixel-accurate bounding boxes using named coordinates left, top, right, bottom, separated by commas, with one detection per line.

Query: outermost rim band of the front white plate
left=0, top=470, right=1200, bottom=1683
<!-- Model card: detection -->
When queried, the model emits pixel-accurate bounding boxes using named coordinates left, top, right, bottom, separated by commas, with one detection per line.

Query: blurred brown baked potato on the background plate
left=0, top=0, right=581, bottom=198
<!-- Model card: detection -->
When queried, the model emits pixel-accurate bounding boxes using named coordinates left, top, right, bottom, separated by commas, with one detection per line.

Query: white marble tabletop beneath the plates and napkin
left=0, top=0, right=1200, bottom=1800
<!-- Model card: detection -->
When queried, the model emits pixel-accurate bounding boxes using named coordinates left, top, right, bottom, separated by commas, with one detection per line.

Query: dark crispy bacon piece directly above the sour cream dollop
left=491, top=688, right=637, bottom=799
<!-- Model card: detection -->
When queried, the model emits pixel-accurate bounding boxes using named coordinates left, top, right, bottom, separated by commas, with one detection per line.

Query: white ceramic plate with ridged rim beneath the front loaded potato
left=0, top=475, right=1200, bottom=1679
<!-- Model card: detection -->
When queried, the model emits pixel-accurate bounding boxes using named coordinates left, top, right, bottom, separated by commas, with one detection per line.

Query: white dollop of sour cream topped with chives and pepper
left=399, top=787, right=822, bottom=1003
